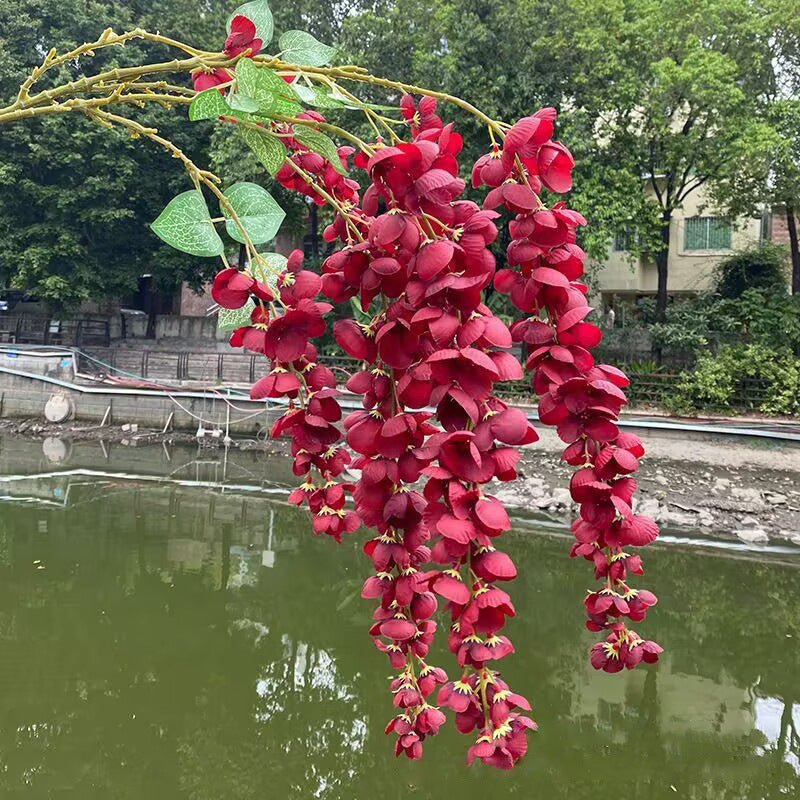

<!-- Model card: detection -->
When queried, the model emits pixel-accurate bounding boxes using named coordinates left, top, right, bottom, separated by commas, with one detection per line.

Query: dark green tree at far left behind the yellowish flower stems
left=0, top=0, right=231, bottom=306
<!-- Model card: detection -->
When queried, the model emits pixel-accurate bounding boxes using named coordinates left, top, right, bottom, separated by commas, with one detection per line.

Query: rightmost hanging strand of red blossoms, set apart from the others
left=484, top=109, right=662, bottom=672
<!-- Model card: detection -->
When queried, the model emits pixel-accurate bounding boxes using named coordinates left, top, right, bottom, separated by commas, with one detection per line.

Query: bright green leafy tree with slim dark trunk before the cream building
left=562, top=0, right=775, bottom=320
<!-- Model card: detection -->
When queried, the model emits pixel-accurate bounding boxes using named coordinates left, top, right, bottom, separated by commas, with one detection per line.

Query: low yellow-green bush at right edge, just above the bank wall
left=669, top=344, right=800, bottom=416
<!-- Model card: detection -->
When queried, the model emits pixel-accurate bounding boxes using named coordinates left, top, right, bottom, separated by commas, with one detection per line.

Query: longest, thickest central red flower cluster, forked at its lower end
left=312, top=97, right=537, bottom=767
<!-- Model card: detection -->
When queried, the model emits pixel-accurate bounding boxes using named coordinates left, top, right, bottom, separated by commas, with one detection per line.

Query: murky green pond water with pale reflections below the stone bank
left=0, top=443, right=800, bottom=800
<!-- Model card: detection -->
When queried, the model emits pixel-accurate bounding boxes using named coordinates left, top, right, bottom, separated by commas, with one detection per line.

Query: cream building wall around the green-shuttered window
left=598, top=183, right=761, bottom=294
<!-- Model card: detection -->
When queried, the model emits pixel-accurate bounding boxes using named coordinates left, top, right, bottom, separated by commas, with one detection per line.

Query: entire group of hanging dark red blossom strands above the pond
left=206, top=78, right=660, bottom=768
